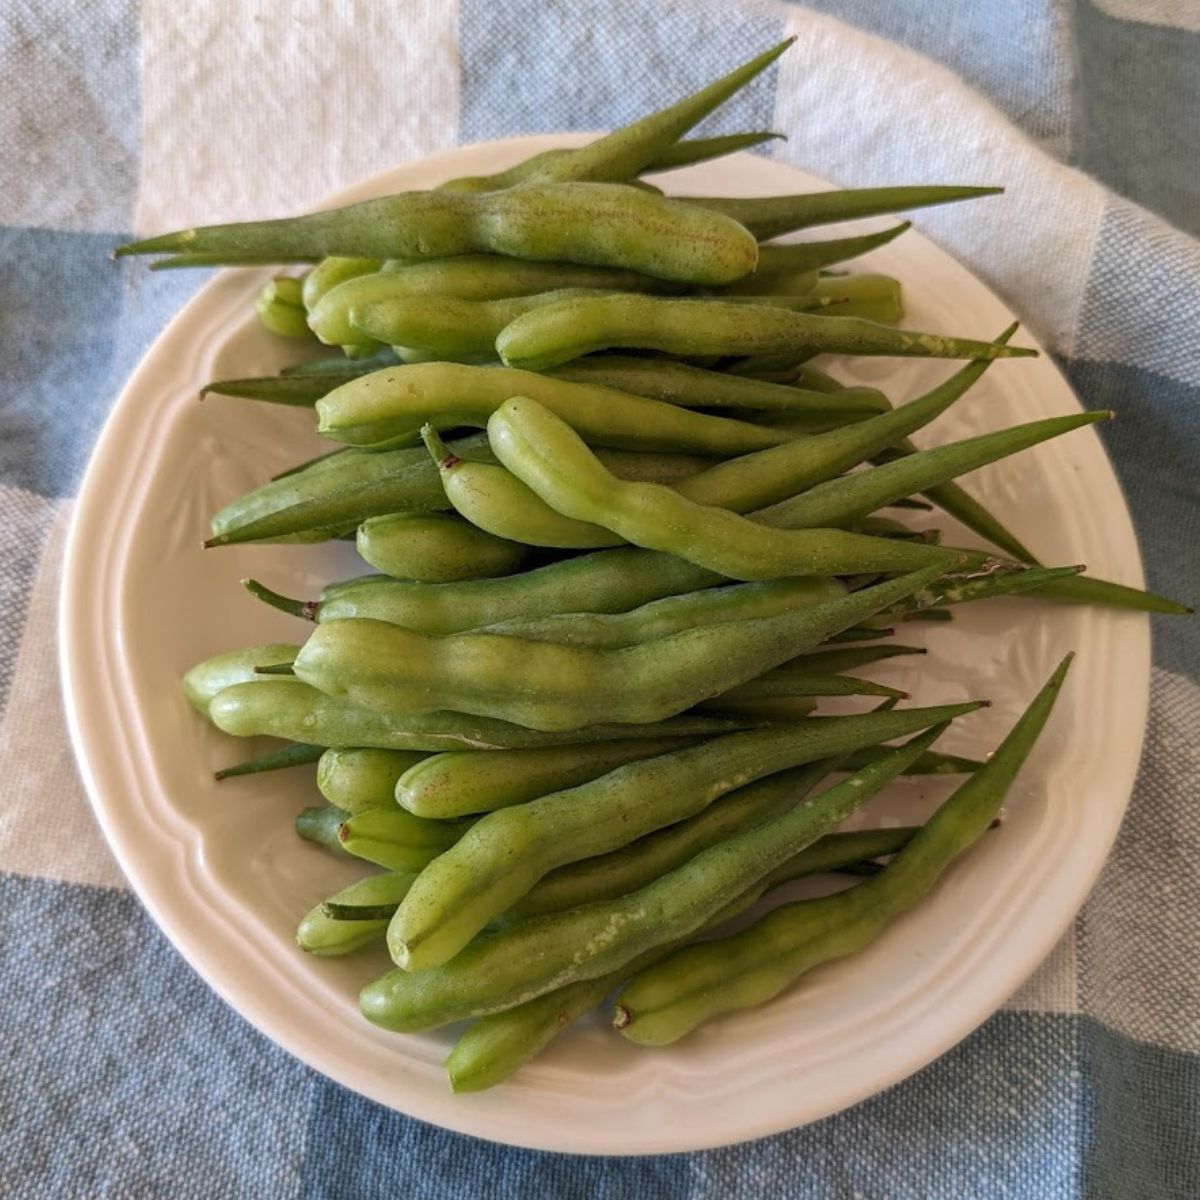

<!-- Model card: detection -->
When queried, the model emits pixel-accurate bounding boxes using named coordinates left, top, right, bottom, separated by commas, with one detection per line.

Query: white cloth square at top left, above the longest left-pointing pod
left=134, top=0, right=458, bottom=234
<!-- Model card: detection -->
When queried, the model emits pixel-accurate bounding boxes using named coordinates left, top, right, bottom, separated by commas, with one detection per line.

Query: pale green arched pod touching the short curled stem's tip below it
left=317, top=362, right=790, bottom=457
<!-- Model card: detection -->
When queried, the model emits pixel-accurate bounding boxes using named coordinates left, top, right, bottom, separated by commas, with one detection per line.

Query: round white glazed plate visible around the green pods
left=60, top=137, right=1150, bottom=1154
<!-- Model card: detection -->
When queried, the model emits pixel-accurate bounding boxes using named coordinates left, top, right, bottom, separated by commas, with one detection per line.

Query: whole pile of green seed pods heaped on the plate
left=119, top=42, right=1188, bottom=1091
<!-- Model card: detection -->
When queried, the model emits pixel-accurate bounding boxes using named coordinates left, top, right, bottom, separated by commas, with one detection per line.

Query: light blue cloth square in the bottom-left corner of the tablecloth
left=0, top=873, right=312, bottom=1200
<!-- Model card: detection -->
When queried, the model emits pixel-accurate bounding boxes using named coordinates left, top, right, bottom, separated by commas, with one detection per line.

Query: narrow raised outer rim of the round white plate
left=56, top=133, right=1151, bottom=1156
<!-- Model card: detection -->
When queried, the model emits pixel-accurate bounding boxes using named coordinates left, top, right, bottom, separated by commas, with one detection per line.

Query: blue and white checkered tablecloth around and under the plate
left=0, top=0, right=1200, bottom=1200
